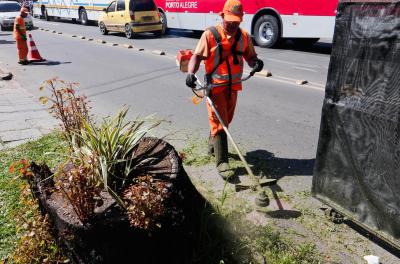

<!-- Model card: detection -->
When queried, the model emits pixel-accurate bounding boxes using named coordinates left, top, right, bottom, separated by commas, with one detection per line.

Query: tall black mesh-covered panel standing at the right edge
left=312, top=1, right=400, bottom=248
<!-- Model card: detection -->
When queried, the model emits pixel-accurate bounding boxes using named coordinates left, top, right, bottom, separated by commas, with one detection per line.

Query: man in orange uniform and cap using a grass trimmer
left=186, top=0, right=264, bottom=179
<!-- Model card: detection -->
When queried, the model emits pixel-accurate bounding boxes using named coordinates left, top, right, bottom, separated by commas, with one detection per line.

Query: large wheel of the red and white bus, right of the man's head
left=253, top=15, right=280, bottom=48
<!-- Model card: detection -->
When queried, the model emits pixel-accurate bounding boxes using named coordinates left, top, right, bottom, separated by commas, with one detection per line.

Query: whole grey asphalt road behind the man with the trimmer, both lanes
left=0, top=20, right=330, bottom=160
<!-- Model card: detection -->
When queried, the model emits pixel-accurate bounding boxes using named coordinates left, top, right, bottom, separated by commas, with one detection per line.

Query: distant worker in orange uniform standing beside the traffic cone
left=14, top=7, right=29, bottom=65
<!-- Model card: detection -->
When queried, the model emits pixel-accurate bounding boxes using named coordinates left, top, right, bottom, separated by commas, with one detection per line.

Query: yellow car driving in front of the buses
left=99, top=0, right=162, bottom=38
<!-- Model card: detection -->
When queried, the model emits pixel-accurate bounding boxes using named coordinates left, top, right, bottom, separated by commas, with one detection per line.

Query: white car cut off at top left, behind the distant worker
left=0, top=1, right=33, bottom=30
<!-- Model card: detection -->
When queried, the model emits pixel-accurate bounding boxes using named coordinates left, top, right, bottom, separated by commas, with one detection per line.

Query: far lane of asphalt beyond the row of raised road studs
left=35, top=19, right=331, bottom=87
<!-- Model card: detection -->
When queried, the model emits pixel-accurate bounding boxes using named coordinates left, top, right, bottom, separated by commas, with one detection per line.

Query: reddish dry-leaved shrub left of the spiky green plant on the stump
left=39, top=78, right=100, bottom=223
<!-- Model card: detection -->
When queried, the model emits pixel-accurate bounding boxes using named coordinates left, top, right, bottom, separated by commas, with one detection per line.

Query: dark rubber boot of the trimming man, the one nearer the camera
left=214, top=132, right=234, bottom=180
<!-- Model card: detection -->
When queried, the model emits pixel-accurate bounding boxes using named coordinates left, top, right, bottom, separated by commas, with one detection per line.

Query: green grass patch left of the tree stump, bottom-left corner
left=0, top=133, right=65, bottom=263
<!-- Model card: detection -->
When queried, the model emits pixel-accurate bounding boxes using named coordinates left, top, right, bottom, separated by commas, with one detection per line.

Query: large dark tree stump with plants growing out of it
left=30, top=137, right=204, bottom=264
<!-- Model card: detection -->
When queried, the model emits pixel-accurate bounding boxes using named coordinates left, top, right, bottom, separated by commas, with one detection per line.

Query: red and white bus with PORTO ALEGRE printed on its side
left=154, top=0, right=338, bottom=47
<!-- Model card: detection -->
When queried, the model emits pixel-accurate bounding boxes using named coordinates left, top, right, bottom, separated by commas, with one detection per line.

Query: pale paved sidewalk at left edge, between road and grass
left=0, top=62, right=57, bottom=150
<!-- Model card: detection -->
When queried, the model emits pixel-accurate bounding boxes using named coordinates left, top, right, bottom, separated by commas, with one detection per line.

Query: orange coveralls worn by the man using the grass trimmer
left=194, top=25, right=257, bottom=137
